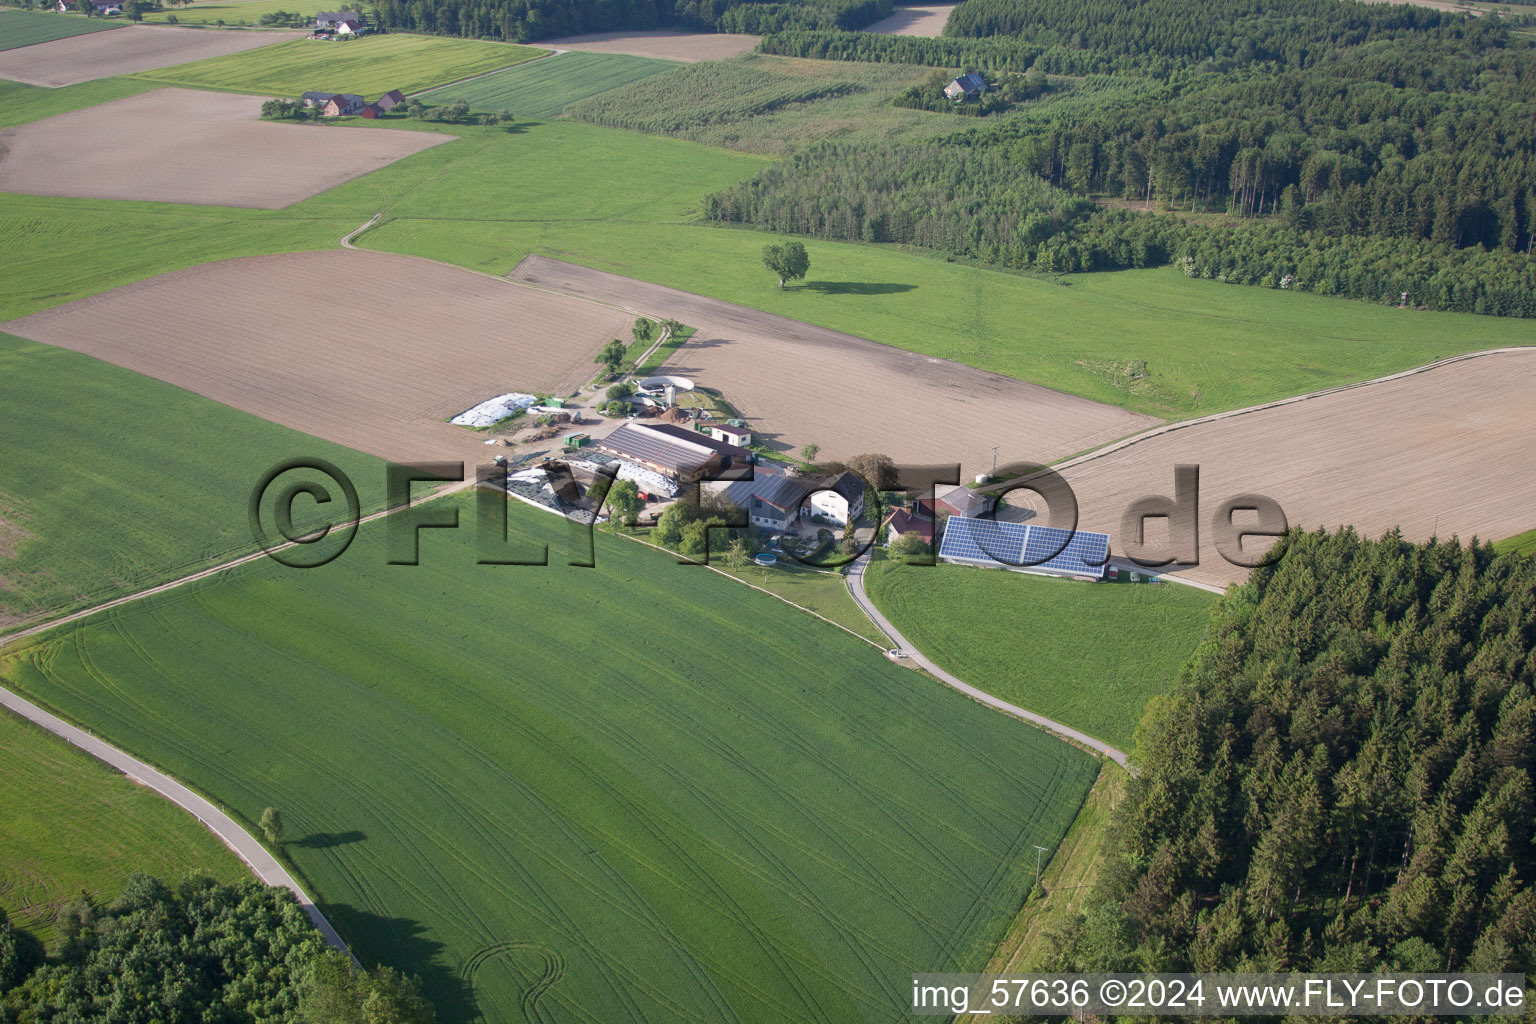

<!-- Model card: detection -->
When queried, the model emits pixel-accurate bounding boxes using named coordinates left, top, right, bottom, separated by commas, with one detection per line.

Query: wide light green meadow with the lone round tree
left=0, top=117, right=1530, bottom=418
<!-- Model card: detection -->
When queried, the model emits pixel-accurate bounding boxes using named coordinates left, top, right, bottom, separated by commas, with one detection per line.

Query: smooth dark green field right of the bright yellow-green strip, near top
left=421, top=51, right=677, bottom=120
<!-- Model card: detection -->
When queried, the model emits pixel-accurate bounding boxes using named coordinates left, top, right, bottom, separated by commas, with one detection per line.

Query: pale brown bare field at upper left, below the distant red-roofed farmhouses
left=0, top=89, right=455, bottom=210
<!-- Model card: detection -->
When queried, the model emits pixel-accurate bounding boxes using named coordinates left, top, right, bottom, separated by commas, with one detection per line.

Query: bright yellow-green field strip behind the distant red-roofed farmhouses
left=132, top=35, right=548, bottom=100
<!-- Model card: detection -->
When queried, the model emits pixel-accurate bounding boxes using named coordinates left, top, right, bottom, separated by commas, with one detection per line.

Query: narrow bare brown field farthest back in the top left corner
left=0, top=25, right=304, bottom=89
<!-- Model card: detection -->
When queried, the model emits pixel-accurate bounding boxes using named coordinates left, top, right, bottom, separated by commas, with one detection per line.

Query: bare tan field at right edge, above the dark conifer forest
left=1063, top=350, right=1536, bottom=586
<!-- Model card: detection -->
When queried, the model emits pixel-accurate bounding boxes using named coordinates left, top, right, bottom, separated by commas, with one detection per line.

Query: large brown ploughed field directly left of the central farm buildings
left=5, top=249, right=631, bottom=464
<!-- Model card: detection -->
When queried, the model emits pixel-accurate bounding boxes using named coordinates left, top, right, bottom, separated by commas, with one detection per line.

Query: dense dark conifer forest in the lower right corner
left=1046, top=531, right=1536, bottom=994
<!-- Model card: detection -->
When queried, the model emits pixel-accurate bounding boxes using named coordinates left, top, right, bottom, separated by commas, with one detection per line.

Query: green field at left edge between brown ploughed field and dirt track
left=0, top=335, right=384, bottom=628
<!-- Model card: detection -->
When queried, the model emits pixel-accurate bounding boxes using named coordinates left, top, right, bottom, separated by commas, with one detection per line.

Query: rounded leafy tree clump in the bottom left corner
left=0, top=875, right=436, bottom=1024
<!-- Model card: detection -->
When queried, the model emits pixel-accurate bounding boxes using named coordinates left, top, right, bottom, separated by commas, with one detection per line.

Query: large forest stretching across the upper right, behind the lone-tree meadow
left=707, top=0, right=1536, bottom=316
